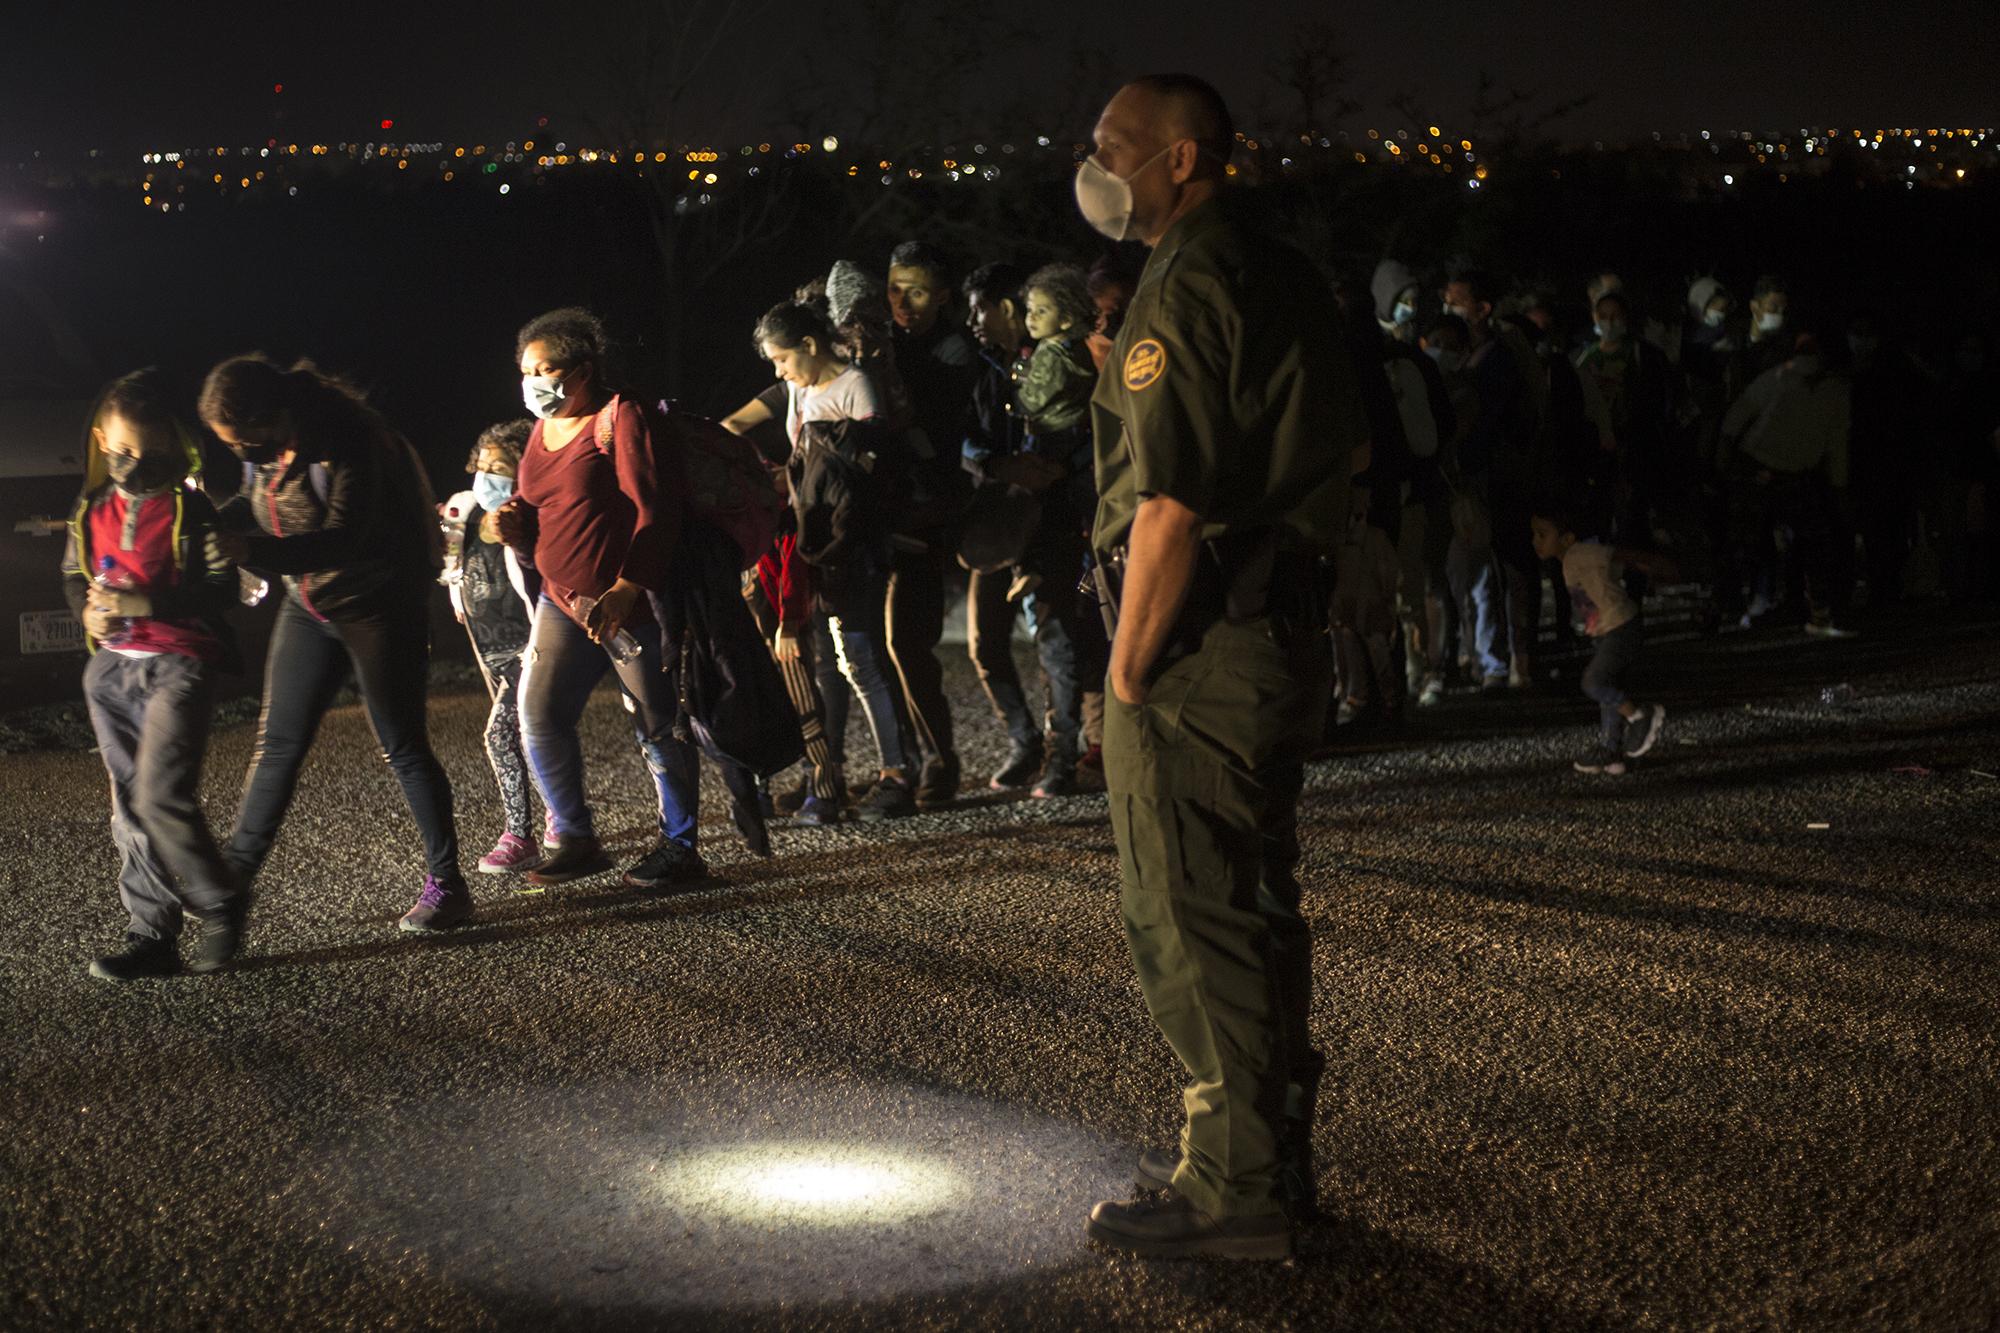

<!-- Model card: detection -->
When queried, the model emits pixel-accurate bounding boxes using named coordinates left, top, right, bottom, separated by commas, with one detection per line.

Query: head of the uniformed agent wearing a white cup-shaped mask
left=1076, top=74, right=1236, bottom=244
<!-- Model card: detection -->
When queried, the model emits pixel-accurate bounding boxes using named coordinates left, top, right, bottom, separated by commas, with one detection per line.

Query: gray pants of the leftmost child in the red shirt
left=84, top=648, right=242, bottom=939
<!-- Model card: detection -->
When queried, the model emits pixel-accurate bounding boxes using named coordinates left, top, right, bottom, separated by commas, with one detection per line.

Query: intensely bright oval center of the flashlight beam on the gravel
left=660, top=1143, right=964, bottom=1227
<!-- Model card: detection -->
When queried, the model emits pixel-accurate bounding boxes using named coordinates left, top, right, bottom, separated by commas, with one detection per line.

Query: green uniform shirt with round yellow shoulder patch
left=1090, top=200, right=1368, bottom=554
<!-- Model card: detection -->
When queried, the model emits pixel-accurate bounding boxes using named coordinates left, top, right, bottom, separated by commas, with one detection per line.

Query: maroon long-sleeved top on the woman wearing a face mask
left=514, top=398, right=684, bottom=624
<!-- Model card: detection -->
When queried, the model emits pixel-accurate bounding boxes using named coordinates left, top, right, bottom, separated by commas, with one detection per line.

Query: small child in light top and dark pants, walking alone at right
left=1532, top=502, right=1666, bottom=777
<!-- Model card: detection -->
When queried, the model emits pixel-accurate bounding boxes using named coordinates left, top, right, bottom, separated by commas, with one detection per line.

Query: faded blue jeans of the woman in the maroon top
left=520, top=594, right=700, bottom=851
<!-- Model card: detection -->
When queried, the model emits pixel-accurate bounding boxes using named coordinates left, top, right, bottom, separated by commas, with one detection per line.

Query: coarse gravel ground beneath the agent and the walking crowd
left=0, top=618, right=2000, bottom=1329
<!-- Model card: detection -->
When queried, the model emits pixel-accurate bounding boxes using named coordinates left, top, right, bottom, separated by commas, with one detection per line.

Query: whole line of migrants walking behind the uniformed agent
left=47, top=195, right=2000, bottom=975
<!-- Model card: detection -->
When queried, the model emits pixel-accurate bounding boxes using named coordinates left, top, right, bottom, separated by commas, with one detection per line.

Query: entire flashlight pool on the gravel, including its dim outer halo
left=312, top=1077, right=1132, bottom=1304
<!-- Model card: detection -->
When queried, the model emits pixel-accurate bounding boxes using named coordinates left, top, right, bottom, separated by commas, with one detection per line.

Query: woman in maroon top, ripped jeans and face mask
left=498, top=308, right=706, bottom=889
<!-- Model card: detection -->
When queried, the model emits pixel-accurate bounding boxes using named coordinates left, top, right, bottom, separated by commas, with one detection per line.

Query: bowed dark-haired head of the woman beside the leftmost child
left=196, top=352, right=386, bottom=464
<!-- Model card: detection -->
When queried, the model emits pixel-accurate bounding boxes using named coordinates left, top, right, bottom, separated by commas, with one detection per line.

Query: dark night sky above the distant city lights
left=15, top=0, right=2000, bottom=154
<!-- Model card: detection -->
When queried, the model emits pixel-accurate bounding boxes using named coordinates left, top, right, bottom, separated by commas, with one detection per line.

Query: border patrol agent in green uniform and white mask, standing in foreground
left=1076, top=74, right=1366, bottom=1259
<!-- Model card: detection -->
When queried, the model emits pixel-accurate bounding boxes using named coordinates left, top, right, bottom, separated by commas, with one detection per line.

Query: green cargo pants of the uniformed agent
left=1104, top=620, right=1332, bottom=1217
